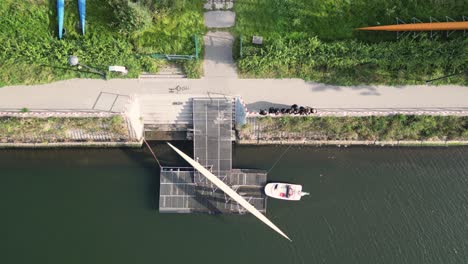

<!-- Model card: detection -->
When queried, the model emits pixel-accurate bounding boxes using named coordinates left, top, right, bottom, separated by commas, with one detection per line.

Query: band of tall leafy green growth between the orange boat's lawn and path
left=238, top=35, right=468, bottom=85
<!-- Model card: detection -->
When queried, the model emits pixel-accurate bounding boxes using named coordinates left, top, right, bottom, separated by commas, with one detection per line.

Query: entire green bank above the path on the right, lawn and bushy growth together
left=235, top=0, right=468, bottom=85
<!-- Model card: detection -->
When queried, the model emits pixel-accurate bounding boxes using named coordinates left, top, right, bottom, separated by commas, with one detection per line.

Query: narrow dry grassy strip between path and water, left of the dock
left=0, top=116, right=128, bottom=142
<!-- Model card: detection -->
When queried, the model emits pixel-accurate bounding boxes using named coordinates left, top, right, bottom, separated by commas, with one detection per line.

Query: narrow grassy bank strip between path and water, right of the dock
left=245, top=115, right=468, bottom=141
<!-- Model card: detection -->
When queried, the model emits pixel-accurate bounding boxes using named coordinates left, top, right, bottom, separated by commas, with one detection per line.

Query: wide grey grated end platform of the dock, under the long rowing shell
left=159, top=167, right=267, bottom=214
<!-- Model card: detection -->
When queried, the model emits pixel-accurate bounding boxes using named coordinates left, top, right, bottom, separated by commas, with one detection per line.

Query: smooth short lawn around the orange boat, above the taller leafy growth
left=234, top=0, right=468, bottom=40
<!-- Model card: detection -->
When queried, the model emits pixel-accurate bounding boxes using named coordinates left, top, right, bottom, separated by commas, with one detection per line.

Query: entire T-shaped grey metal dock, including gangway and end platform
left=159, top=97, right=267, bottom=214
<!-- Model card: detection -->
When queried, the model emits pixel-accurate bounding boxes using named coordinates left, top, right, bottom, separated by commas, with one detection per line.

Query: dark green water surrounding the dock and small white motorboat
left=0, top=144, right=468, bottom=264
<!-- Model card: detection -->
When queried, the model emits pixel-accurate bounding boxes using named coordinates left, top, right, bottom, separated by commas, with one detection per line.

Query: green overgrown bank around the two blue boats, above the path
left=0, top=0, right=205, bottom=86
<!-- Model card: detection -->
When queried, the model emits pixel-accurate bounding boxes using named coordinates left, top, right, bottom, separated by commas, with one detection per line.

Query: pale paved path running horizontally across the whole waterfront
left=0, top=78, right=468, bottom=113
